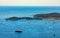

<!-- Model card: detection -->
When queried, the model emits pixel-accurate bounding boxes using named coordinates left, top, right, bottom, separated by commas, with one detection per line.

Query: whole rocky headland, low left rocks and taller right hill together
left=5, top=13, right=60, bottom=20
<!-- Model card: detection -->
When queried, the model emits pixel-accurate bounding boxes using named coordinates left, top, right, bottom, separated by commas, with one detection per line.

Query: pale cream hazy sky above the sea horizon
left=0, top=0, right=60, bottom=6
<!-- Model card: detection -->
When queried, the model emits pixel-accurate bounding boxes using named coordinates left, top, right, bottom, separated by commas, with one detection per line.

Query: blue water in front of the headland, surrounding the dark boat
left=0, top=19, right=60, bottom=38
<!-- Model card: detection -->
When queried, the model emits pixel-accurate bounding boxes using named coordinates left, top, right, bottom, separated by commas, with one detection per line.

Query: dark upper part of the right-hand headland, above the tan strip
left=34, top=13, right=60, bottom=18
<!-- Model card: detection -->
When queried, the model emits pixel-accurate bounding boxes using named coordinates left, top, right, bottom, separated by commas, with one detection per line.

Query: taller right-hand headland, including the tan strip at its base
left=34, top=13, right=60, bottom=20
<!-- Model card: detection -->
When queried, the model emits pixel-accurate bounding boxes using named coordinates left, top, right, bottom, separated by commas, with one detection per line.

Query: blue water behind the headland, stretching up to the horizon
left=0, top=6, right=60, bottom=18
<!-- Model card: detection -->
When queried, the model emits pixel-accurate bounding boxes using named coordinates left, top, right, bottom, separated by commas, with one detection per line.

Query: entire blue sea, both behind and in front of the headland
left=0, top=6, right=60, bottom=38
